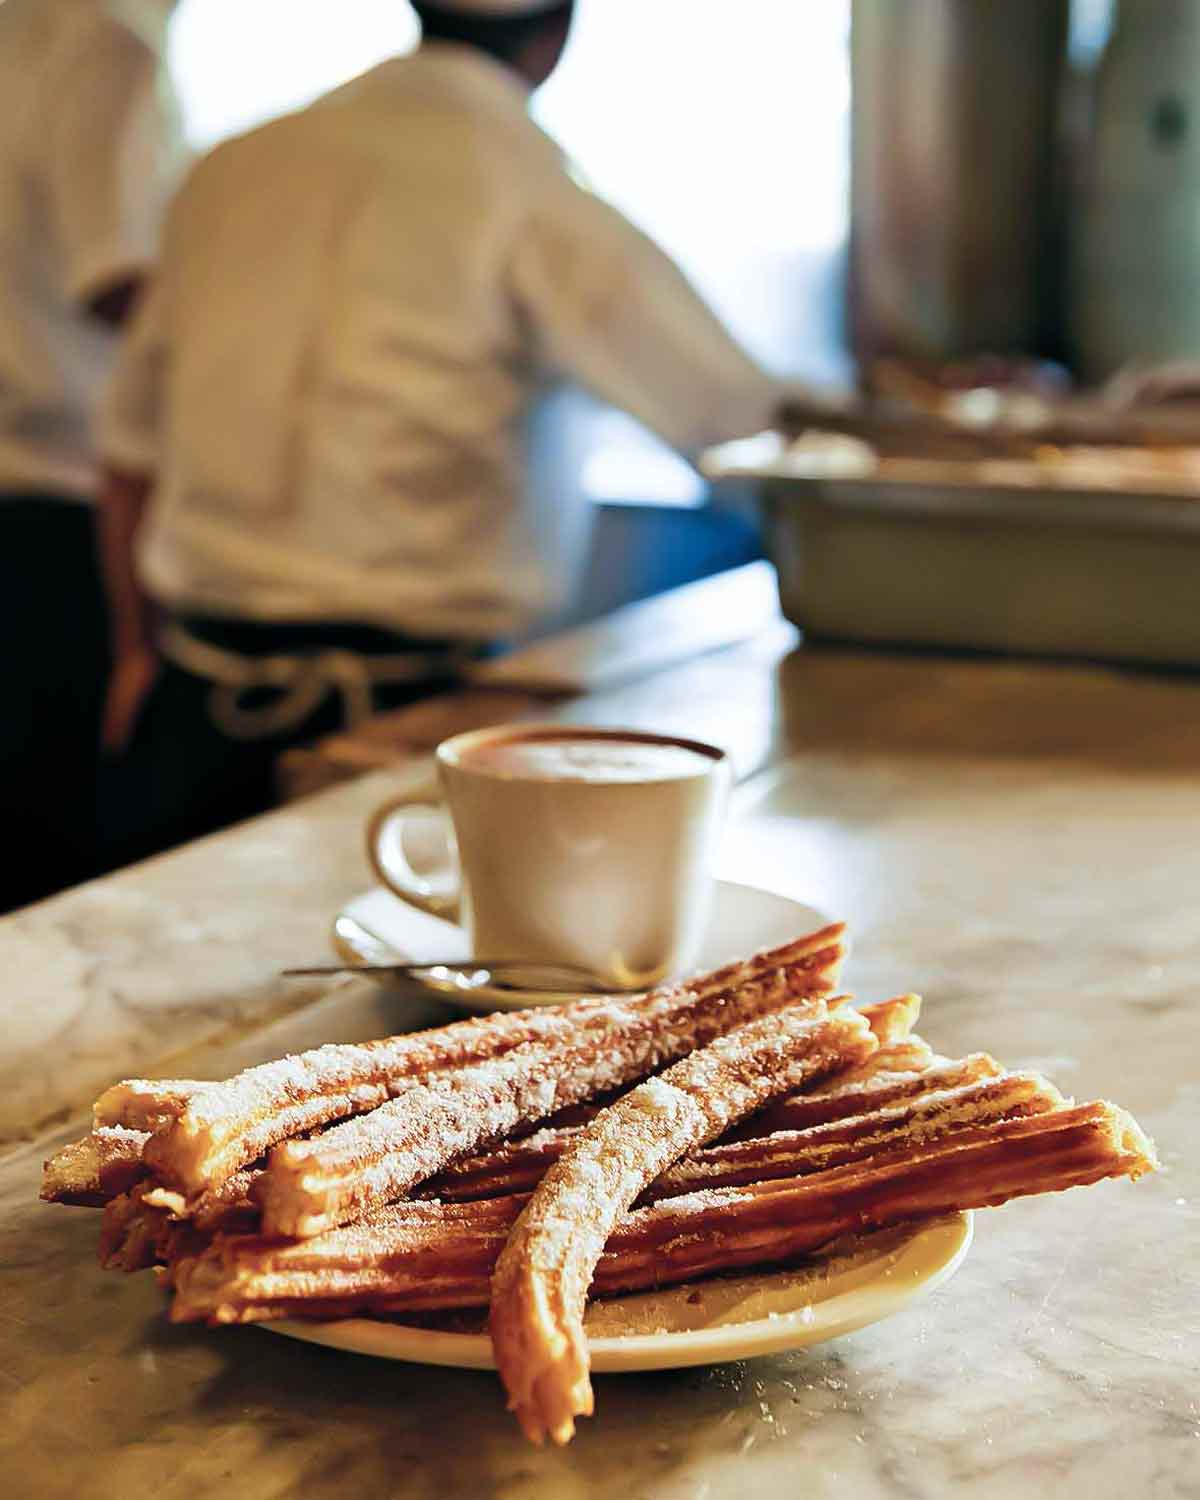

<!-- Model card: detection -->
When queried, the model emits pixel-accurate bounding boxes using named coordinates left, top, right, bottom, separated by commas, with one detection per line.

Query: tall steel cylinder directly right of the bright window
left=851, top=0, right=1068, bottom=356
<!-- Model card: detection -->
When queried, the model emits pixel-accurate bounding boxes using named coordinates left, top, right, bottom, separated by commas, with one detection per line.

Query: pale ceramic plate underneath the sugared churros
left=260, top=1214, right=972, bottom=1373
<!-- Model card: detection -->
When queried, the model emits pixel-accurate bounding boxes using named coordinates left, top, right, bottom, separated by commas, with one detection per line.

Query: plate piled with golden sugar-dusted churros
left=42, top=924, right=1157, bottom=1443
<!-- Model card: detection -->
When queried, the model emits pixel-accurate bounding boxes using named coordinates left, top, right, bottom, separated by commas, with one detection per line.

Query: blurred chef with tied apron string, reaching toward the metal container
left=102, top=0, right=777, bottom=863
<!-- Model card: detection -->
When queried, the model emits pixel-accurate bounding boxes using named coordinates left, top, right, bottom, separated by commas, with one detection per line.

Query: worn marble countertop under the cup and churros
left=0, top=632, right=1200, bottom=1500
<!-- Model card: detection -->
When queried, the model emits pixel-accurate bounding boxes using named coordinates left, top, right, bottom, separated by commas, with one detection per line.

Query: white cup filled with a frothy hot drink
left=368, top=725, right=732, bottom=990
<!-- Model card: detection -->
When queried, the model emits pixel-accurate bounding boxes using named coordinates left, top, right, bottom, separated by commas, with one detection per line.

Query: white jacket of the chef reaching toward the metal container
left=102, top=44, right=776, bottom=638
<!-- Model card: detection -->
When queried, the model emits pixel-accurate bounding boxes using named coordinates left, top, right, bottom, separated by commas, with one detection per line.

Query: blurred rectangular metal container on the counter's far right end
left=743, top=473, right=1200, bottom=666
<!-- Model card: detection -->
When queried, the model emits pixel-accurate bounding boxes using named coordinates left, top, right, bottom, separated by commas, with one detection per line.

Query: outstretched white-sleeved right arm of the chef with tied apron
left=509, top=162, right=783, bottom=453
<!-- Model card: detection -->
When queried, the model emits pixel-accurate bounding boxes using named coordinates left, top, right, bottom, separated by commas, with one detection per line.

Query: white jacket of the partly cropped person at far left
left=0, top=0, right=182, bottom=500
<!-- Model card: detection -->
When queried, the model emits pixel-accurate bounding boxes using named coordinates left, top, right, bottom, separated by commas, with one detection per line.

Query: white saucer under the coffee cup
left=333, top=881, right=831, bottom=1013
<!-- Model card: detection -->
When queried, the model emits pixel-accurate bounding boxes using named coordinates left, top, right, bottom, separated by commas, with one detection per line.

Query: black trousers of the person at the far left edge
left=0, top=492, right=108, bottom=912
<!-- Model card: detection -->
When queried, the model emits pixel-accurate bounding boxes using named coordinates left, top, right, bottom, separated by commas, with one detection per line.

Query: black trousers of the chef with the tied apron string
left=98, top=618, right=465, bottom=870
